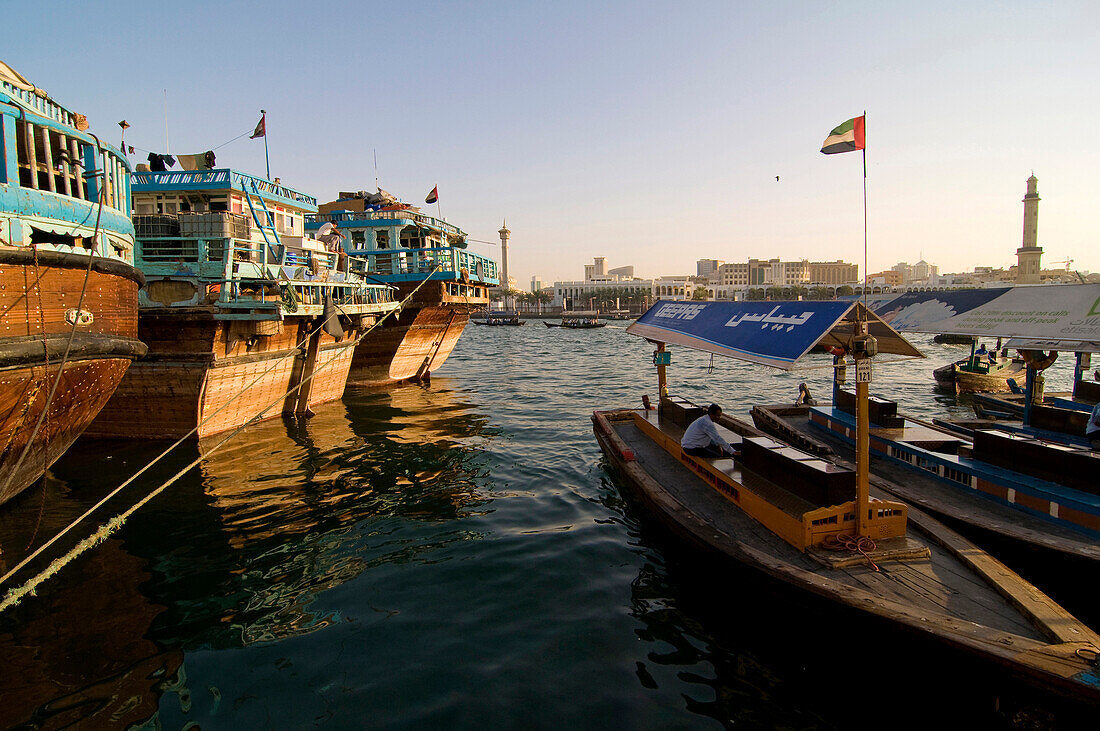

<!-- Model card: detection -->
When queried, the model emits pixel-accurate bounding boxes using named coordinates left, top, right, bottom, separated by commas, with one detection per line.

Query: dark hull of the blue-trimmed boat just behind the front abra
left=752, top=406, right=1100, bottom=565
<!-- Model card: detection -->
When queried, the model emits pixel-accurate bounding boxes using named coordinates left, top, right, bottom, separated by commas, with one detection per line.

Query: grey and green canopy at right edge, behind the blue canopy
left=879, top=284, right=1100, bottom=353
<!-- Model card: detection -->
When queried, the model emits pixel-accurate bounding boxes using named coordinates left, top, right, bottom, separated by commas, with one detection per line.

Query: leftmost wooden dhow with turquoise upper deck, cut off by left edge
left=0, top=63, right=145, bottom=502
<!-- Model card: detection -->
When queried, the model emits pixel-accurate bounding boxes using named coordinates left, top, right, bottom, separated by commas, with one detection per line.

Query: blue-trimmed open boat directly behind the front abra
left=752, top=400, right=1100, bottom=562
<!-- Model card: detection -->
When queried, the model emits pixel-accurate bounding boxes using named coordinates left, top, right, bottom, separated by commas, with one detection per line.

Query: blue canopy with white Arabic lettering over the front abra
left=626, top=301, right=924, bottom=370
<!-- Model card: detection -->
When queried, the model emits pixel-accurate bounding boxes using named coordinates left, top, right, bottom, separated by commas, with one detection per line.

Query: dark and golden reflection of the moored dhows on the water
left=0, top=378, right=494, bottom=728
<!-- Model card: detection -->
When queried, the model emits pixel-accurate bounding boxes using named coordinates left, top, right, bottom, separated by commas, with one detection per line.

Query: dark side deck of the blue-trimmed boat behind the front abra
left=758, top=407, right=1100, bottom=561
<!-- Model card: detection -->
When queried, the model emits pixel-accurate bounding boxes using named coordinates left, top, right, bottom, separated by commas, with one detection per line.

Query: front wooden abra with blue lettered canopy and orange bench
left=593, top=302, right=1100, bottom=701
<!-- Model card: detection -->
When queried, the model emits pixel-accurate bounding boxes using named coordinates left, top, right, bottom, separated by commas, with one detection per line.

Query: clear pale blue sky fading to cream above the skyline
left=0, top=0, right=1100, bottom=288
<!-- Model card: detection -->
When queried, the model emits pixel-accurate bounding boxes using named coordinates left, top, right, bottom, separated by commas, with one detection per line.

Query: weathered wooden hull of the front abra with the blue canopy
left=593, top=411, right=1100, bottom=702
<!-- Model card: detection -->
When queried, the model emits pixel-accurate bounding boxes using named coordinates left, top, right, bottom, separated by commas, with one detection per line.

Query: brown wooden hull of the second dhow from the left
left=87, top=308, right=373, bottom=439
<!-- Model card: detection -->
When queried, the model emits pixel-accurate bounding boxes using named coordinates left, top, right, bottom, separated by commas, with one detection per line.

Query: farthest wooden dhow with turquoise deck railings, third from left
left=306, top=190, right=499, bottom=386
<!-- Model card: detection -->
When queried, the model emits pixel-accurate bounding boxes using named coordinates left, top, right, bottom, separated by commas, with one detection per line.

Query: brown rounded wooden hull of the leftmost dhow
left=0, top=250, right=145, bottom=502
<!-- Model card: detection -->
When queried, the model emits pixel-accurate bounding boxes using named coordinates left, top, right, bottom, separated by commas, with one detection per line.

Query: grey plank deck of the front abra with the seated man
left=612, top=411, right=1045, bottom=640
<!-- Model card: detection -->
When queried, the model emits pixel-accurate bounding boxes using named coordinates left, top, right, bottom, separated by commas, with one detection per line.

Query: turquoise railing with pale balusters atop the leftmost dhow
left=0, top=82, right=131, bottom=218
